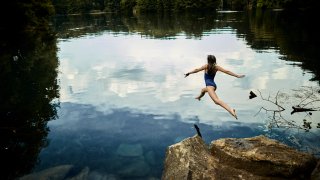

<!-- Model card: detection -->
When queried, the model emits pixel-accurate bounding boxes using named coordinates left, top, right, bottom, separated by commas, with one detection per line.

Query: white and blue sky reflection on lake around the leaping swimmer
left=38, top=26, right=319, bottom=178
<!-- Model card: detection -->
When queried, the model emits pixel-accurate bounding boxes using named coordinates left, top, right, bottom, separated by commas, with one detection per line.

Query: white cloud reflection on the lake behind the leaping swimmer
left=59, top=33, right=315, bottom=123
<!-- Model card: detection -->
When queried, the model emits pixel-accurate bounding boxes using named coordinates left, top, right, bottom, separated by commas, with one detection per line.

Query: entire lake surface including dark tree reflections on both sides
left=1, top=11, right=320, bottom=179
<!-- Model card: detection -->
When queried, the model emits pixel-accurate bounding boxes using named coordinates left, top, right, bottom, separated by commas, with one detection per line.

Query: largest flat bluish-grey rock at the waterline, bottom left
left=19, top=165, right=73, bottom=180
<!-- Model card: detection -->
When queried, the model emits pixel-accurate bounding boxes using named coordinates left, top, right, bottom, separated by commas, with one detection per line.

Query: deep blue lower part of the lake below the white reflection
left=37, top=103, right=262, bottom=178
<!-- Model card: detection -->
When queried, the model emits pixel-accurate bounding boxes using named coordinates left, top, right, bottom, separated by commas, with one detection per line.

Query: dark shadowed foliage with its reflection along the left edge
left=0, top=0, right=59, bottom=179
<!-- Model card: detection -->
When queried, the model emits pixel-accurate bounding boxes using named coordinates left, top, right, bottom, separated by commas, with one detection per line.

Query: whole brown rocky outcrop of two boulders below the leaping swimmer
left=162, top=135, right=319, bottom=180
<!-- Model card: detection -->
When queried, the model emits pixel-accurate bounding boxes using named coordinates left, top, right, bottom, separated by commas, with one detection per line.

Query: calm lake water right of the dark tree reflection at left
left=16, top=12, right=320, bottom=179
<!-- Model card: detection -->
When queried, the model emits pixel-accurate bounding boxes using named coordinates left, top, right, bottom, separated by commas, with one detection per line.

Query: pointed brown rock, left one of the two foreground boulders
left=161, top=135, right=263, bottom=180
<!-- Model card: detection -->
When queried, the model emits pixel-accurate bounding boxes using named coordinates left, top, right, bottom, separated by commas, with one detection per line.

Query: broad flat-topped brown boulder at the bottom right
left=210, top=136, right=317, bottom=179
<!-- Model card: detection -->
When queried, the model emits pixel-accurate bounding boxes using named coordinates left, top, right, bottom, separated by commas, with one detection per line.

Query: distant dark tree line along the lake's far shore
left=53, top=0, right=319, bottom=14
